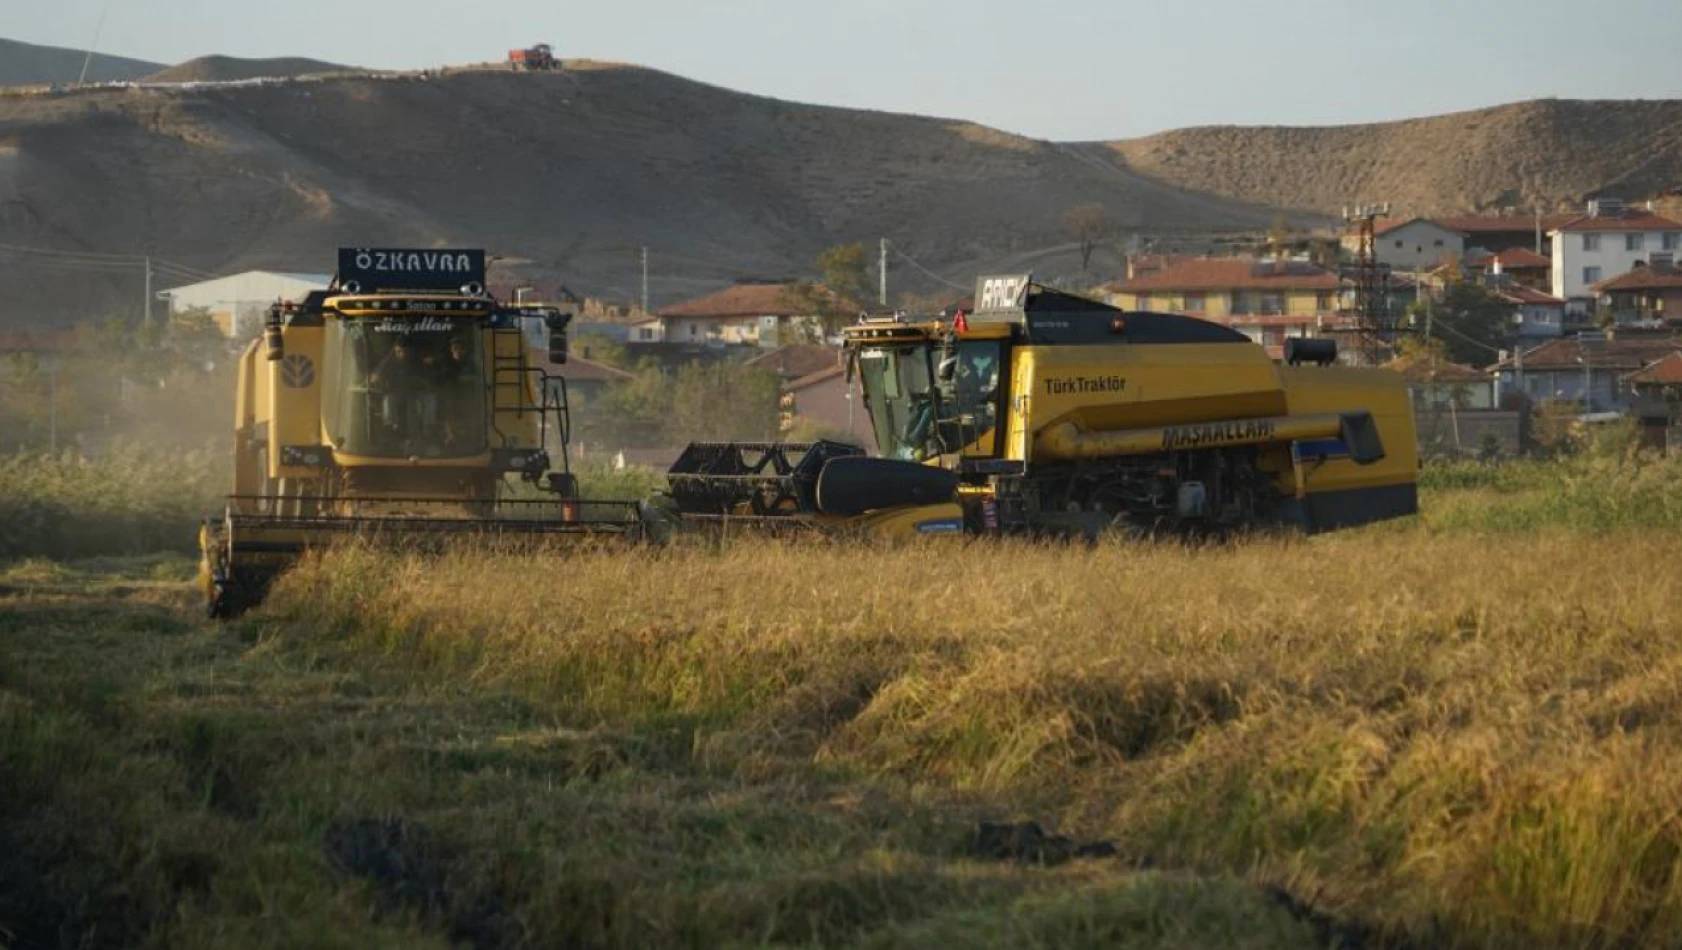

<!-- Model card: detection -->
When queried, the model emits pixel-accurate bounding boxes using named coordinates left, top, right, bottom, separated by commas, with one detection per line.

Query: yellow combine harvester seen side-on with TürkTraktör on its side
left=668, top=274, right=1418, bottom=536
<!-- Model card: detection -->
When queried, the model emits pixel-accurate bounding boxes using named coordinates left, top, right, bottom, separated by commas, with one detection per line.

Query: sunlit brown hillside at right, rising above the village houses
left=1107, top=99, right=1682, bottom=214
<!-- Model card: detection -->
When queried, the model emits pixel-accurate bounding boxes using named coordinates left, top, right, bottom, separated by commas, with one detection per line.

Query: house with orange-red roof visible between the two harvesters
left=659, top=279, right=858, bottom=348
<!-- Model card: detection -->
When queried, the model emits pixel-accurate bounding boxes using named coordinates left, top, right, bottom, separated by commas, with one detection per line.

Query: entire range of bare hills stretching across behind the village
left=0, top=57, right=1682, bottom=323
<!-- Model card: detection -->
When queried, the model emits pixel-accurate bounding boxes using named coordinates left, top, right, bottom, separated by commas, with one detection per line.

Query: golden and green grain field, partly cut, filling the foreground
left=0, top=457, right=1682, bottom=947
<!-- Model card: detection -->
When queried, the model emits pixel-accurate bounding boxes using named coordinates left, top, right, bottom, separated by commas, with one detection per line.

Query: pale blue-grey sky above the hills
left=0, top=0, right=1682, bottom=140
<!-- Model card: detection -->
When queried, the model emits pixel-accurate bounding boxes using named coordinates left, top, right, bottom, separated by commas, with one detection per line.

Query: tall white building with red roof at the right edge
left=1547, top=200, right=1682, bottom=313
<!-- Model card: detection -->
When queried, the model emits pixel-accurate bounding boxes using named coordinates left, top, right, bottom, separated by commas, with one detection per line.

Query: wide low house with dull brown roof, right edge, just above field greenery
left=1489, top=333, right=1682, bottom=412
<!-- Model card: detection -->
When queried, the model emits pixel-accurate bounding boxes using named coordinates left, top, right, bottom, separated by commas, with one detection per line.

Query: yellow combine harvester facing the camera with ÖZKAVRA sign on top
left=200, top=249, right=641, bottom=617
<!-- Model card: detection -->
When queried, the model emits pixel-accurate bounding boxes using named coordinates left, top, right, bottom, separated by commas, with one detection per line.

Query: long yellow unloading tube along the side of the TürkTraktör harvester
left=1034, top=412, right=1384, bottom=466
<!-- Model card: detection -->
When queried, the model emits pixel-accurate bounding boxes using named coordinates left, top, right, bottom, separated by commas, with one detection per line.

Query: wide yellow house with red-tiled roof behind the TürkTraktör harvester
left=1103, top=257, right=1347, bottom=358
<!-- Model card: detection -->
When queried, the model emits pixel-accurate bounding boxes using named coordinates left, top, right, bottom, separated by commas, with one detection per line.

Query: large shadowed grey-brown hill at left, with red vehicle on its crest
left=0, top=66, right=1275, bottom=316
